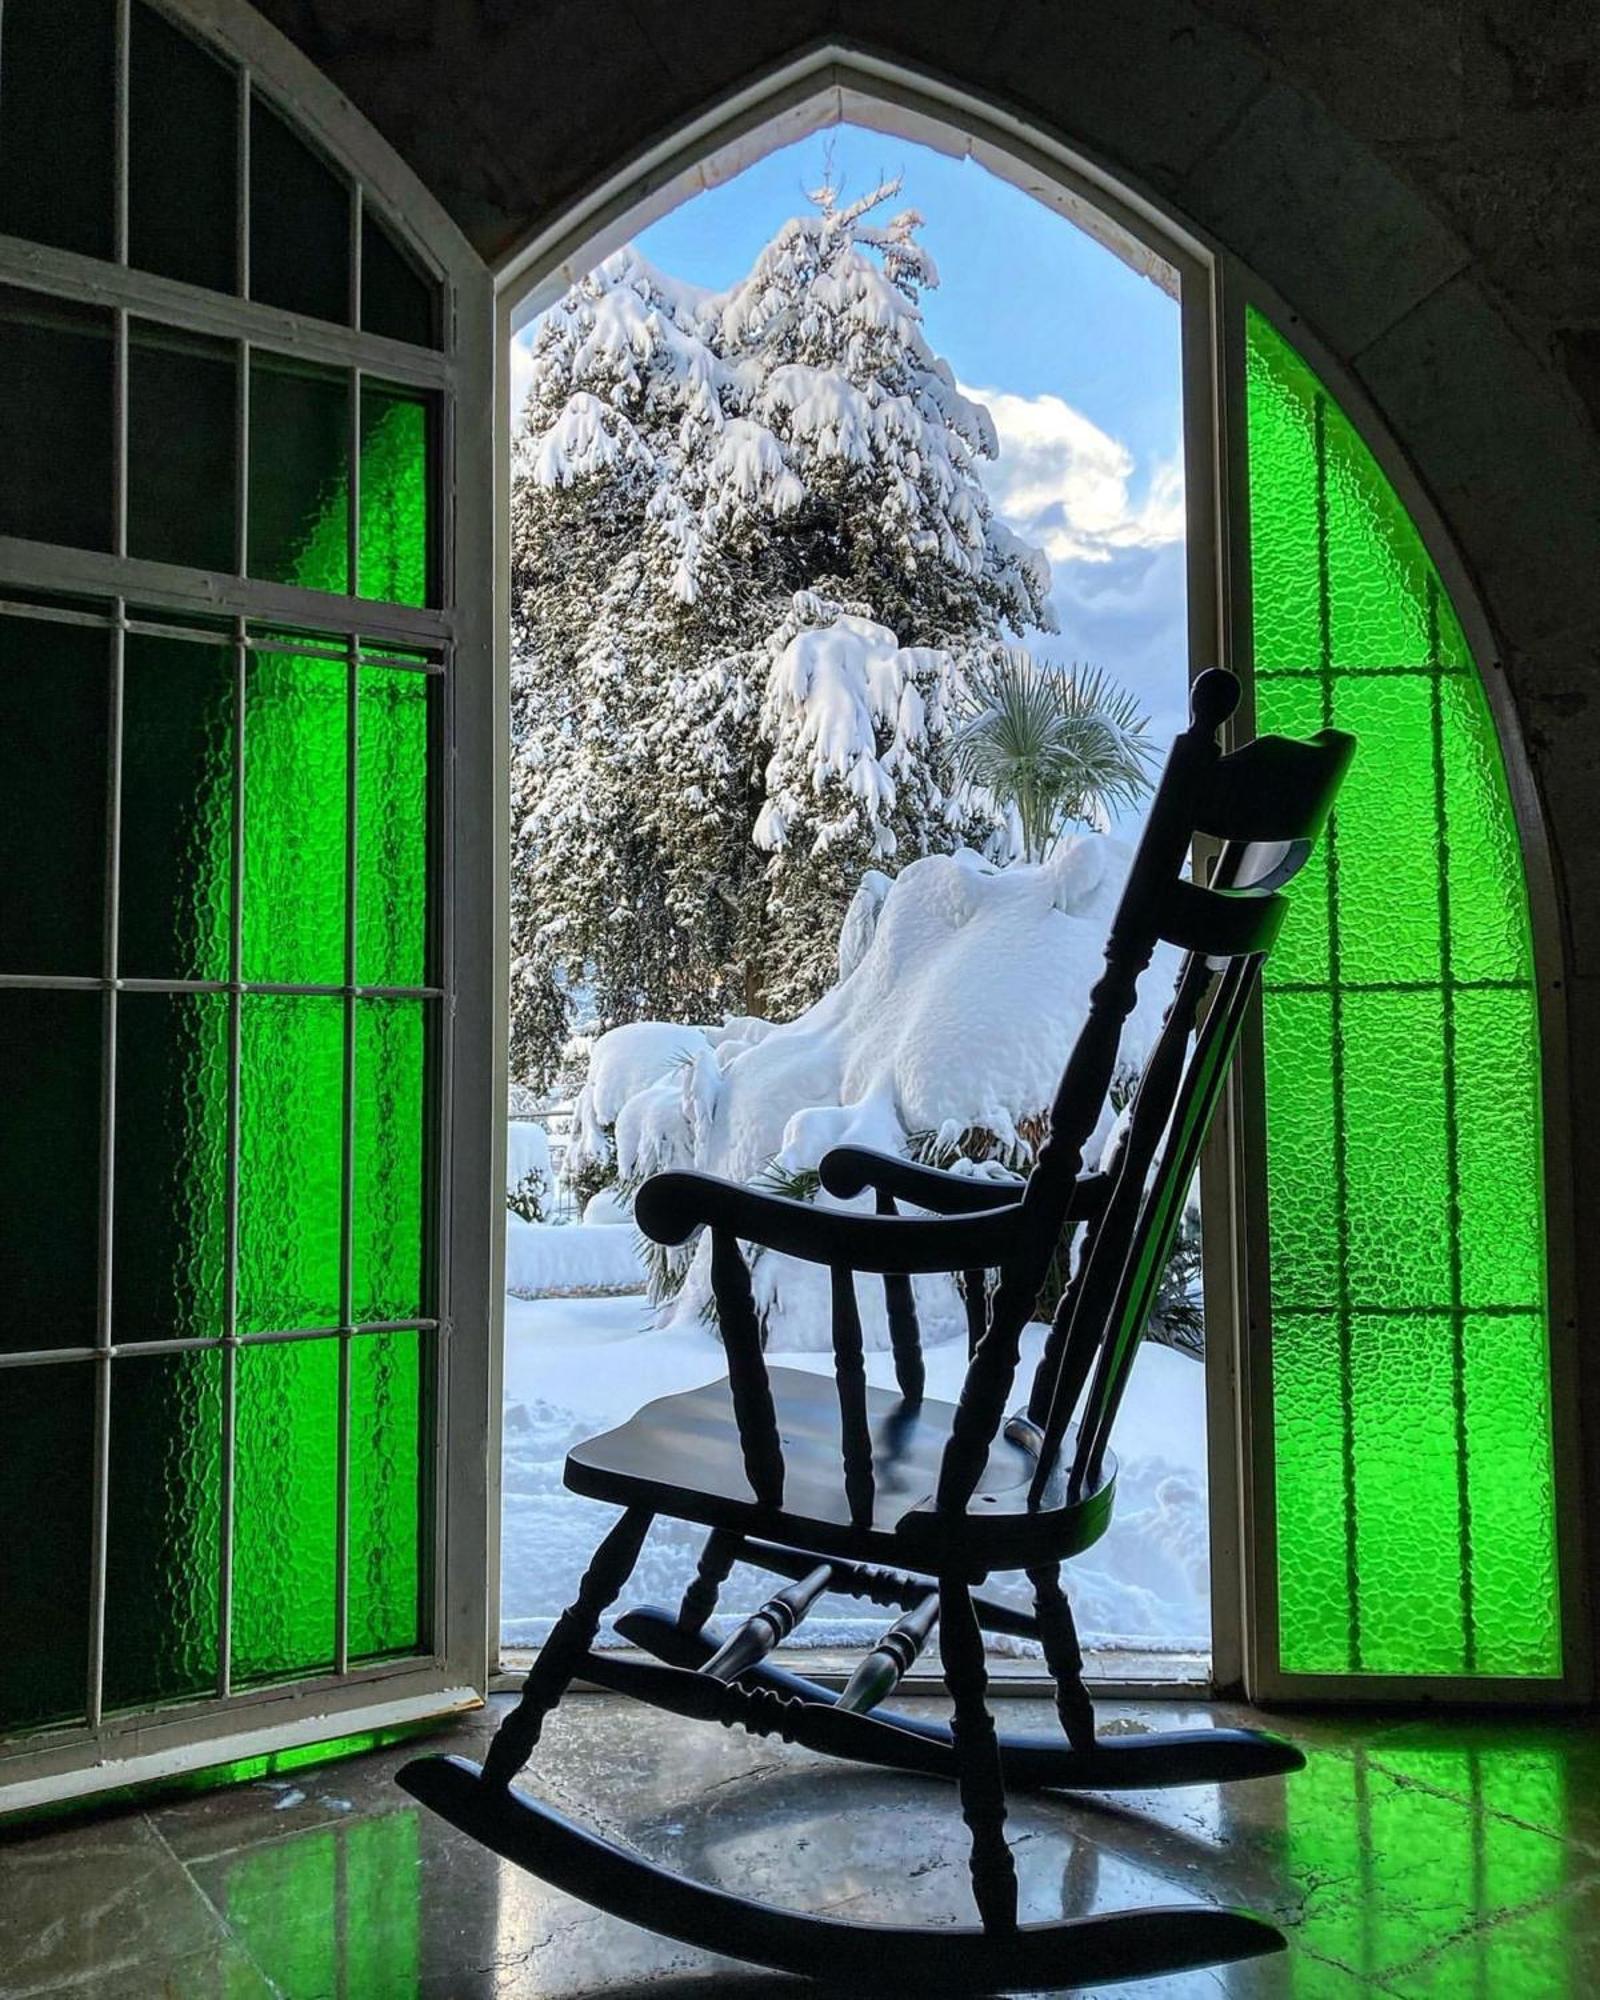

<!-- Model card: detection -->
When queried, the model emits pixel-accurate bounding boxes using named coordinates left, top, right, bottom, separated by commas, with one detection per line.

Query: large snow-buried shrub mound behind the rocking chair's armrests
left=580, top=834, right=1174, bottom=1350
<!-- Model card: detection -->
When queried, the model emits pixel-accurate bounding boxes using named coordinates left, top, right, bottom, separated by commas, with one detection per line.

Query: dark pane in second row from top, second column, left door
left=128, top=320, right=238, bottom=576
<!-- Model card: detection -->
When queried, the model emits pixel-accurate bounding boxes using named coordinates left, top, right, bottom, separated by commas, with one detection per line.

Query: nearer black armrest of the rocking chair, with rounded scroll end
left=634, top=1172, right=1022, bottom=1274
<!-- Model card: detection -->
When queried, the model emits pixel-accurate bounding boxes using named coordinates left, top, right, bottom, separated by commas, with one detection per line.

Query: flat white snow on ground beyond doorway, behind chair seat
left=500, top=1288, right=1210, bottom=1652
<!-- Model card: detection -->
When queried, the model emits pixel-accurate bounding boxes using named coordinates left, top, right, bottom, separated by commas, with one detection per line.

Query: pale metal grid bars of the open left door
left=0, top=0, right=476, bottom=1778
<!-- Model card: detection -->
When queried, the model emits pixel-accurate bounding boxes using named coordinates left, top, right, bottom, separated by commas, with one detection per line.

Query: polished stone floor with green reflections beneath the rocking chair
left=0, top=1696, right=1600, bottom=2000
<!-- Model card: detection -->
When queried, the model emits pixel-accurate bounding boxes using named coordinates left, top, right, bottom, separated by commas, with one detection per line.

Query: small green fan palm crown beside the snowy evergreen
left=952, top=646, right=1156, bottom=862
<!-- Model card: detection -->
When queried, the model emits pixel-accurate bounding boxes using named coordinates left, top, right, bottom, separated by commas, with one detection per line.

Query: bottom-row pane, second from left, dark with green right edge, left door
left=106, top=1348, right=222, bottom=1708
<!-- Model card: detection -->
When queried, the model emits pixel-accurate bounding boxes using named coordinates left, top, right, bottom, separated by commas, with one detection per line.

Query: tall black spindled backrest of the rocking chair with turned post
left=938, top=670, right=1356, bottom=1510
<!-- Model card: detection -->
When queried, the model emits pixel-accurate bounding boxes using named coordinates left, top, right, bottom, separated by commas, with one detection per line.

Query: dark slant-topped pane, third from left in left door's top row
left=250, top=98, right=350, bottom=326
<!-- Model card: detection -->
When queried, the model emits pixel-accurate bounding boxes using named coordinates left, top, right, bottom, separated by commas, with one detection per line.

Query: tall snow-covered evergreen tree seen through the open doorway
left=512, top=170, right=1050, bottom=1080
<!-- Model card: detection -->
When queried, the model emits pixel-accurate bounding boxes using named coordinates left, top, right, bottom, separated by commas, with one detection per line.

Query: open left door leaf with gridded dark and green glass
left=0, top=0, right=492, bottom=1796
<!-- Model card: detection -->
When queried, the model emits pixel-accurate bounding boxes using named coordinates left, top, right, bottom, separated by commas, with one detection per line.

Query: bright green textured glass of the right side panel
left=1246, top=312, right=1562, bottom=1680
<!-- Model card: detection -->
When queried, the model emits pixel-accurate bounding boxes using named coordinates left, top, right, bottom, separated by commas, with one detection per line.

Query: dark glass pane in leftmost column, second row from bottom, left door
left=0, top=988, right=102, bottom=1352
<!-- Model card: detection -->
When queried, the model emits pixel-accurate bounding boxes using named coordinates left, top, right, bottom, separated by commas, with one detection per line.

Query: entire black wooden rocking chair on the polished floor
left=400, top=670, right=1354, bottom=1994
